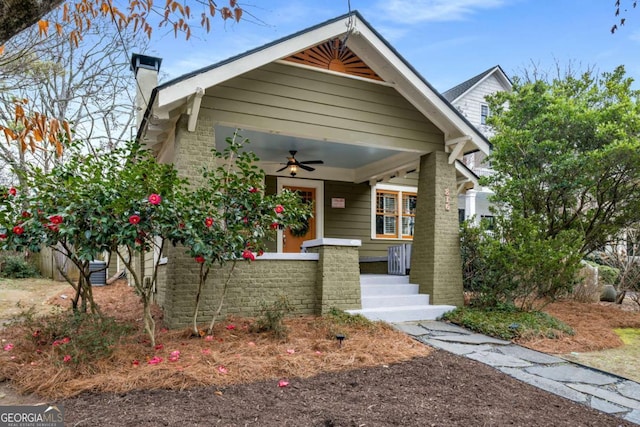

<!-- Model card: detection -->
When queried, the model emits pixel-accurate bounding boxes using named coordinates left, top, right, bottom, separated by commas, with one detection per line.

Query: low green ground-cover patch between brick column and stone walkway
left=443, top=306, right=574, bottom=340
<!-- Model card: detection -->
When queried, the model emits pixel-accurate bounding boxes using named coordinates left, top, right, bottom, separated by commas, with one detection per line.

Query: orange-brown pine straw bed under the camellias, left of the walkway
left=0, top=282, right=431, bottom=399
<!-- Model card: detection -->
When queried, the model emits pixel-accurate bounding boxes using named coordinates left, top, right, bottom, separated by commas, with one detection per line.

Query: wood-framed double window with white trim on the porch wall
left=373, top=186, right=418, bottom=240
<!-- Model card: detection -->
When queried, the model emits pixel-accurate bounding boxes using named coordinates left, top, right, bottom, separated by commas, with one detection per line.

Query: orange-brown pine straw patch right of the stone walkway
left=516, top=300, right=640, bottom=354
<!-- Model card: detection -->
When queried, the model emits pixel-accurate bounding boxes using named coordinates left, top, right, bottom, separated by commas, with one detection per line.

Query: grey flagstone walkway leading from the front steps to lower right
left=394, top=320, right=640, bottom=425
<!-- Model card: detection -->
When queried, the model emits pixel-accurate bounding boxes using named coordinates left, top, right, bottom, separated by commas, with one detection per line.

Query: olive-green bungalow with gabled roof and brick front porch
left=132, top=12, right=489, bottom=326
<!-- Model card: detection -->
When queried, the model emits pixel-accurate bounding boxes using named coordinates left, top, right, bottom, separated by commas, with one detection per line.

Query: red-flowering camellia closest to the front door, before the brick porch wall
left=179, top=132, right=311, bottom=335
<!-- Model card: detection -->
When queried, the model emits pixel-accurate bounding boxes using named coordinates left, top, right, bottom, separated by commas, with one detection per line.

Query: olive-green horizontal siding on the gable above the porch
left=200, top=64, right=443, bottom=151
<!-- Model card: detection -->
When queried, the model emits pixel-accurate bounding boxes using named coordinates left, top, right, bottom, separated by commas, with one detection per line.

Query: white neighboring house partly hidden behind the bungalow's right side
left=442, top=65, right=512, bottom=227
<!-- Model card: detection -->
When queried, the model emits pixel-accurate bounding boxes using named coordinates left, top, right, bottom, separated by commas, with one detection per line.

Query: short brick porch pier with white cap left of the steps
left=302, top=239, right=362, bottom=314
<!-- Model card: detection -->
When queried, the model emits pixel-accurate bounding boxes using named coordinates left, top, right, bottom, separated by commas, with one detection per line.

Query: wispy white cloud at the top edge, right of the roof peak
left=377, top=0, right=506, bottom=24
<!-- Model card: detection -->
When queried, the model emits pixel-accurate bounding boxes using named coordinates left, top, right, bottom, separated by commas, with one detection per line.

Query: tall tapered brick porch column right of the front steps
left=410, top=151, right=463, bottom=306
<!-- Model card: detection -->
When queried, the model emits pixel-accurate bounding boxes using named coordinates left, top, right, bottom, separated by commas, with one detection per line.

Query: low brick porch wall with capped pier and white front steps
left=155, top=238, right=455, bottom=328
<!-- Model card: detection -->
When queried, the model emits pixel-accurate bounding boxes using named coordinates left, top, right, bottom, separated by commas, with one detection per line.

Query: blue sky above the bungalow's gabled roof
left=141, top=0, right=640, bottom=92
